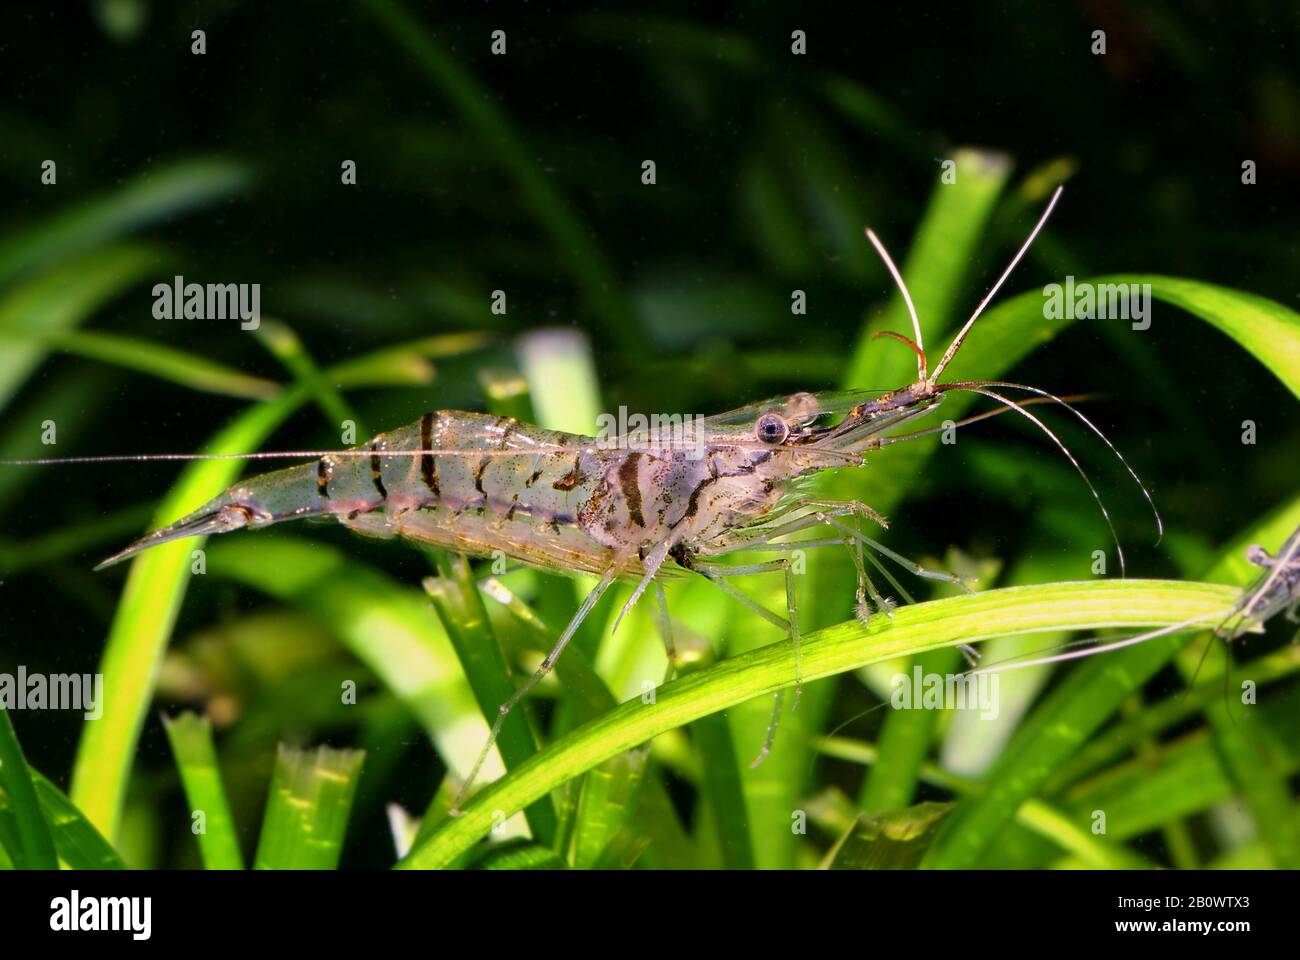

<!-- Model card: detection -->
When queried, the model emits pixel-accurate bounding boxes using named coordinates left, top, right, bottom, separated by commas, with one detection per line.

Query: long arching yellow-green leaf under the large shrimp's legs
left=400, top=580, right=1236, bottom=868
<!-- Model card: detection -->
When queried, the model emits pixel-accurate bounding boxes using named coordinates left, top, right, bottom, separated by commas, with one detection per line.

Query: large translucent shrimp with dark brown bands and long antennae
left=0, top=187, right=1160, bottom=809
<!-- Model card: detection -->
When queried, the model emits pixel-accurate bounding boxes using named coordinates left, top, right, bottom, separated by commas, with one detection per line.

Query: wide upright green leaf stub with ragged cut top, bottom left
left=254, top=744, right=365, bottom=870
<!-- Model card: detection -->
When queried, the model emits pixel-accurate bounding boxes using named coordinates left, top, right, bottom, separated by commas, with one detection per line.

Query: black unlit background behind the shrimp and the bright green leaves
left=0, top=1, right=1300, bottom=861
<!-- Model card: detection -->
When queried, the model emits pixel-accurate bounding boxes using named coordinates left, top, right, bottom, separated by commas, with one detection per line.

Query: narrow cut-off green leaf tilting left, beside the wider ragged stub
left=163, top=713, right=243, bottom=870
